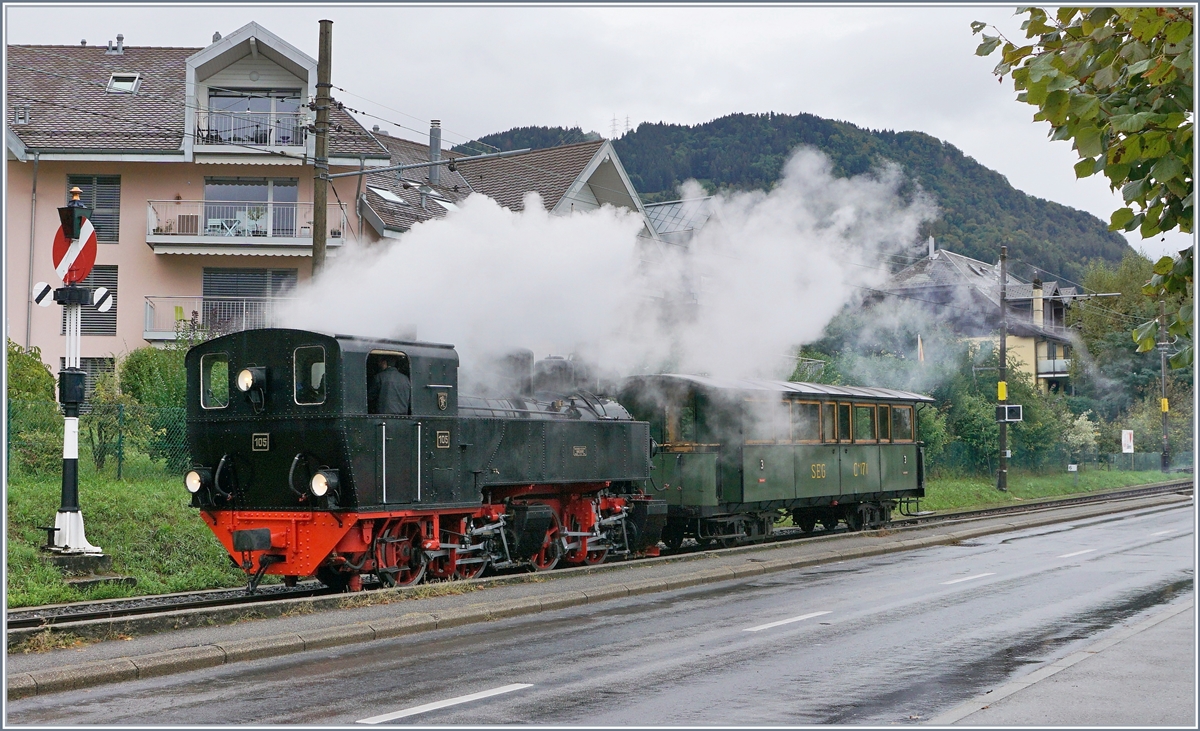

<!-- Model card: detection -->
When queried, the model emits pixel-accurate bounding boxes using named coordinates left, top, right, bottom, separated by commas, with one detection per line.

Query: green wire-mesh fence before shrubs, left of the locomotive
left=6, top=399, right=191, bottom=479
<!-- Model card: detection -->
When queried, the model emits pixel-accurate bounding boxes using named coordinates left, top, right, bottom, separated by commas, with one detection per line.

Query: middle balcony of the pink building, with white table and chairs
left=146, top=200, right=347, bottom=257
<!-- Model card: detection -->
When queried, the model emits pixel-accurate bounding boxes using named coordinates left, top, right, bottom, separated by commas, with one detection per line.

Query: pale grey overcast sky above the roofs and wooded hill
left=5, top=4, right=1190, bottom=265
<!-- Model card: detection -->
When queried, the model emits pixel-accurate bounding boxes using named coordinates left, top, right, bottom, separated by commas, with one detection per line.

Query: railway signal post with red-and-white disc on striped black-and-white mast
left=45, top=187, right=102, bottom=556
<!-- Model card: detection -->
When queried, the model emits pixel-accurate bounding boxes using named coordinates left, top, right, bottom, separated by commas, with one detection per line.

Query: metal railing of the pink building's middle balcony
left=146, top=200, right=346, bottom=242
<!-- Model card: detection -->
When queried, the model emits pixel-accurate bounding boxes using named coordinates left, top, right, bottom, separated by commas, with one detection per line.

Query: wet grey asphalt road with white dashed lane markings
left=7, top=504, right=1194, bottom=726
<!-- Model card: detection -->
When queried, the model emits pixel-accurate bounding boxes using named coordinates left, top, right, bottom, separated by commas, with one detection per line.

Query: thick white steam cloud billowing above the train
left=282, top=149, right=936, bottom=377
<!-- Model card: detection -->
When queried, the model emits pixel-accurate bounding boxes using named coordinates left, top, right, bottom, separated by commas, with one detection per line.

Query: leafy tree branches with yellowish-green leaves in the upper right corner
left=971, top=7, right=1194, bottom=367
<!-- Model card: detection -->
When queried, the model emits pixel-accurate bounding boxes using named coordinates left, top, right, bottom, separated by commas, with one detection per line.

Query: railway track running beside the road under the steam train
left=7, top=479, right=1193, bottom=630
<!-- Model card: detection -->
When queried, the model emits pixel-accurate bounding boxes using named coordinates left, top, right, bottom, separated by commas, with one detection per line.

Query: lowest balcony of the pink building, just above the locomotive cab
left=142, top=296, right=290, bottom=341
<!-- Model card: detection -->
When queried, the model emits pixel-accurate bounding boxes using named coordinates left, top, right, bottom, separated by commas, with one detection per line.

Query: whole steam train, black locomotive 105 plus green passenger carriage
left=184, top=329, right=930, bottom=591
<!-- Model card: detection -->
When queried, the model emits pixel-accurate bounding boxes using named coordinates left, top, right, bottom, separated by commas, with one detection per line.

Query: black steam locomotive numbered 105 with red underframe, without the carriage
left=185, top=329, right=666, bottom=591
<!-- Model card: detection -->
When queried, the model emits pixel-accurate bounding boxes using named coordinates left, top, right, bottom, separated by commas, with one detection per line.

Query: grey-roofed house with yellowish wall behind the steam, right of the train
left=872, top=242, right=1078, bottom=390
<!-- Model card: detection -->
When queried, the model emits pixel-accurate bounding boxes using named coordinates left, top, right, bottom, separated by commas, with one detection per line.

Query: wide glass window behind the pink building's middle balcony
left=204, top=178, right=300, bottom=236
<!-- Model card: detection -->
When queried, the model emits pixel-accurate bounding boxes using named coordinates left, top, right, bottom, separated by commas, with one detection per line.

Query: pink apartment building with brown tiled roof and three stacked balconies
left=5, top=23, right=390, bottom=388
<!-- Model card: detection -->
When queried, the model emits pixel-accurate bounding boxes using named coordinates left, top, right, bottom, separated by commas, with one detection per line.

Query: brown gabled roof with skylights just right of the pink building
left=360, top=120, right=659, bottom=241
